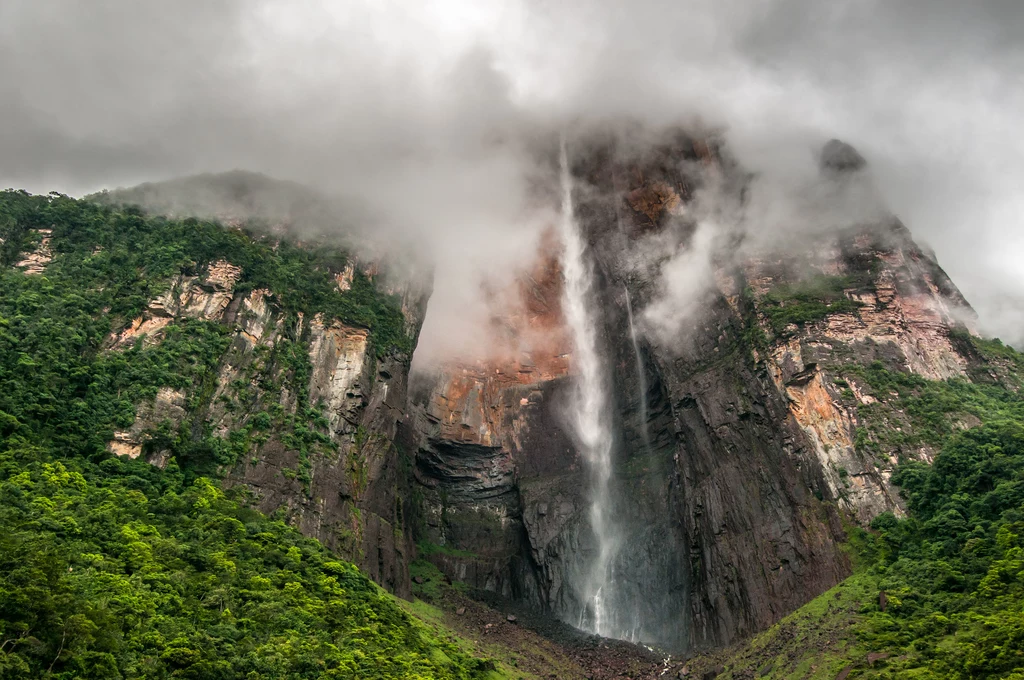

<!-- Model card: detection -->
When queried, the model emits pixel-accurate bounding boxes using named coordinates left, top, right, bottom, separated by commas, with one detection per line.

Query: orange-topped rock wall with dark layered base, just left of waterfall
left=414, top=243, right=579, bottom=603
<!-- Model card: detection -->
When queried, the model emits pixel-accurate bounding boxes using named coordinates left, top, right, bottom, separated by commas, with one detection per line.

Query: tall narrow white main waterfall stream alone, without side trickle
left=559, top=138, right=621, bottom=637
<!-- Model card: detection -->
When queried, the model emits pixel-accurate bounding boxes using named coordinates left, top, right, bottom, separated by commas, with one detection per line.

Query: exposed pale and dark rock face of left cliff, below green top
left=106, top=261, right=425, bottom=596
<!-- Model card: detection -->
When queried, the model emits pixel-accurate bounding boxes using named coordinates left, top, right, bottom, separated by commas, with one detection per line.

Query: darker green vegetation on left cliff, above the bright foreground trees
left=0, top=186, right=411, bottom=474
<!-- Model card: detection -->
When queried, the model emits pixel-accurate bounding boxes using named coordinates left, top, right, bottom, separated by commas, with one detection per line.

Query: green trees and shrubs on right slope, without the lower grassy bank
left=848, top=348, right=1024, bottom=679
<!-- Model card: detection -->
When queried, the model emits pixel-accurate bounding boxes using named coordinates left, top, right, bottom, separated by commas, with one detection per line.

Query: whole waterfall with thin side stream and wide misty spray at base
left=556, top=138, right=689, bottom=646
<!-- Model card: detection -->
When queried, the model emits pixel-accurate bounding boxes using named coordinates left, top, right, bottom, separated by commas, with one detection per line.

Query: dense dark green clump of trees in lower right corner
left=860, top=420, right=1024, bottom=679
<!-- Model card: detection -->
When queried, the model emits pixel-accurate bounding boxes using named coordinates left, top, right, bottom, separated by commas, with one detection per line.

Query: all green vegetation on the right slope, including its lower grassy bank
left=700, top=339, right=1024, bottom=680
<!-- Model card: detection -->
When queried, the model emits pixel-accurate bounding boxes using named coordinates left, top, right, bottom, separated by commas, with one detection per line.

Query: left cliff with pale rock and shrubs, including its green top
left=3, top=195, right=427, bottom=597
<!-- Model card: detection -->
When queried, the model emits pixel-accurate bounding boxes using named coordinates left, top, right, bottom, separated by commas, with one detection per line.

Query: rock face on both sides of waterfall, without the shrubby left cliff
left=403, top=135, right=972, bottom=648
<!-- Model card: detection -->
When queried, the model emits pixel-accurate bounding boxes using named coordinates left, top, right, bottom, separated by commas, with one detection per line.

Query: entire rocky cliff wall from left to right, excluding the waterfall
left=9, top=133, right=991, bottom=650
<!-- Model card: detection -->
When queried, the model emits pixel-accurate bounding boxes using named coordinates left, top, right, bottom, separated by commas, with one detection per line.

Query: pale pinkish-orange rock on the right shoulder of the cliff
left=742, top=221, right=974, bottom=522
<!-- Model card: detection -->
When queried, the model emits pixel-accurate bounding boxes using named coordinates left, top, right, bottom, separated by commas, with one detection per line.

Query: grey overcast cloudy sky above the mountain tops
left=0, top=0, right=1024, bottom=342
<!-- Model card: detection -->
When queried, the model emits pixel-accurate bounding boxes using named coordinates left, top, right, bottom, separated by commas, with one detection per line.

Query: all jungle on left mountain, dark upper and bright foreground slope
left=0, top=192, right=493, bottom=680
